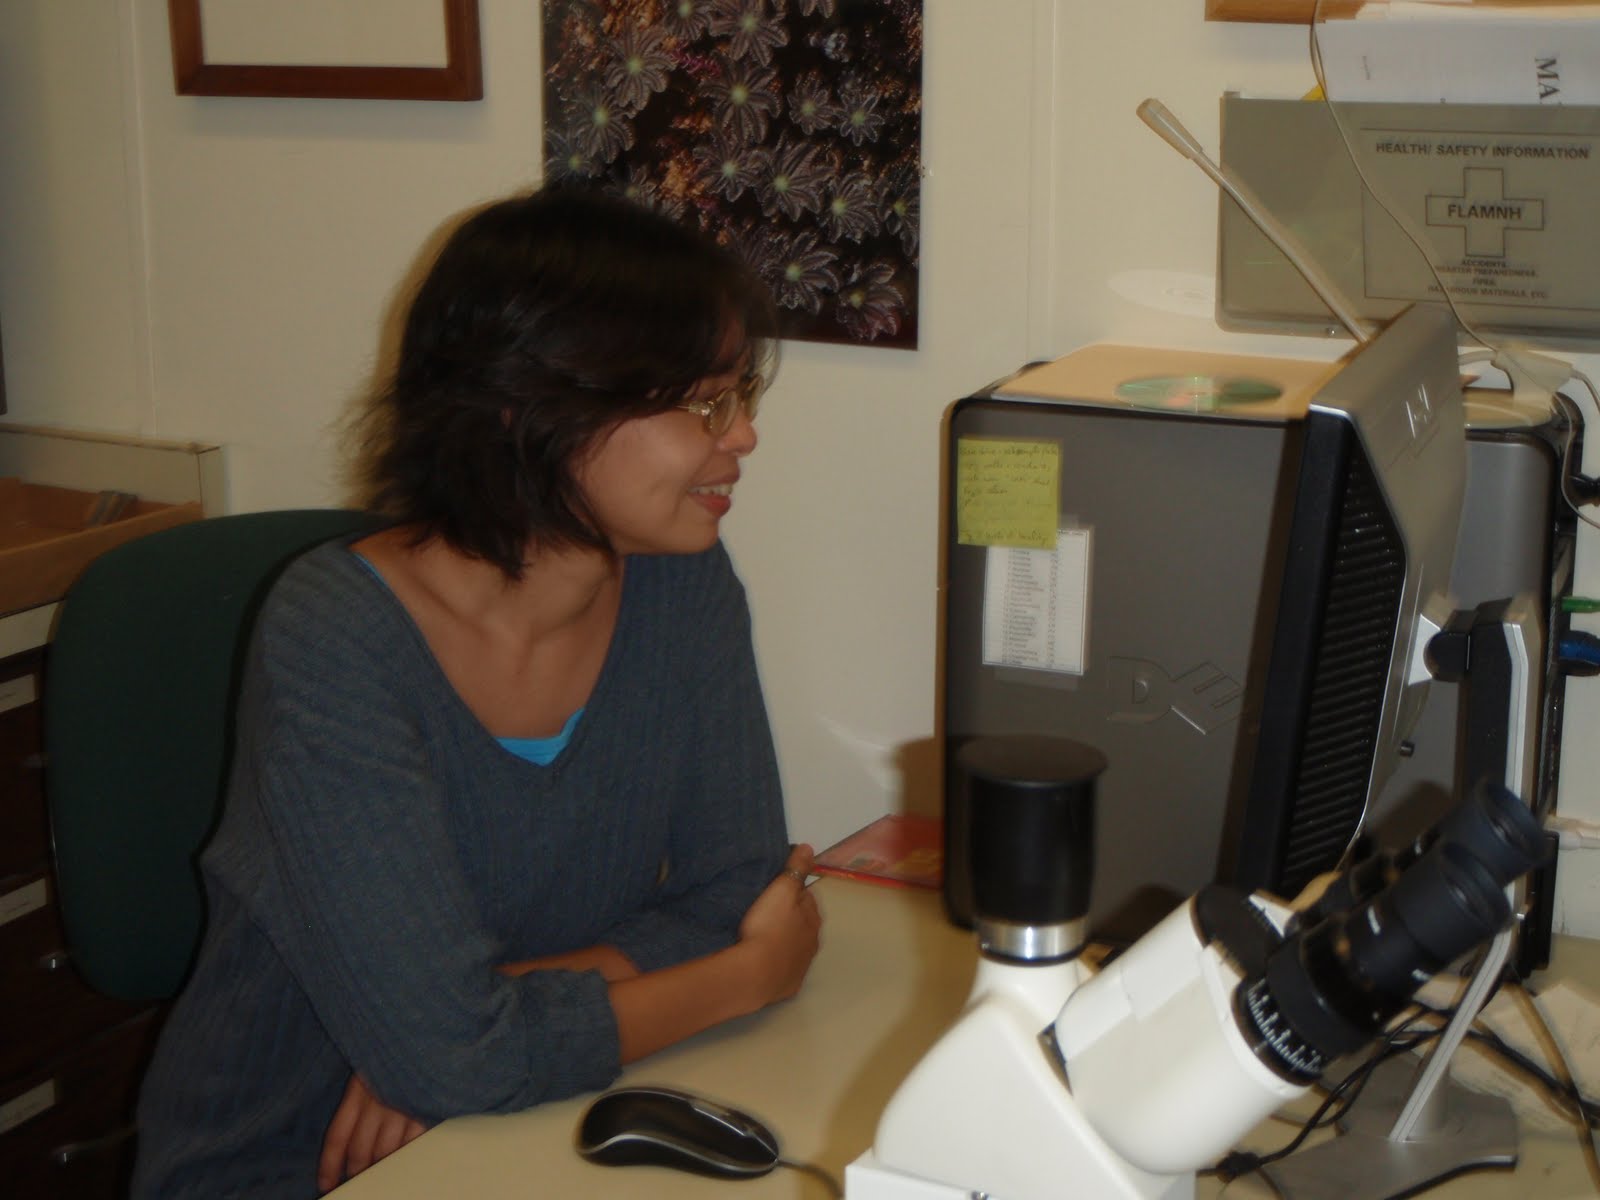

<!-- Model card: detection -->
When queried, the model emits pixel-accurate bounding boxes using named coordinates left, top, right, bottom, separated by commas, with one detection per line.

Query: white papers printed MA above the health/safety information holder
left=1317, top=0, right=1600, bottom=104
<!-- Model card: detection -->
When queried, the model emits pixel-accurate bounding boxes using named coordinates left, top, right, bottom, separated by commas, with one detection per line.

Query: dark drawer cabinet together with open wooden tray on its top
left=0, top=426, right=226, bottom=1200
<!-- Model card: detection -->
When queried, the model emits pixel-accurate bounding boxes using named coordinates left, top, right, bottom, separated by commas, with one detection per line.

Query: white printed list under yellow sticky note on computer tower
left=984, top=530, right=1090, bottom=675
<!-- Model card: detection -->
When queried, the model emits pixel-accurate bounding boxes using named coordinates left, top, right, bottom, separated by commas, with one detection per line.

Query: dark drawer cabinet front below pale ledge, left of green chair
left=0, top=650, right=163, bottom=1200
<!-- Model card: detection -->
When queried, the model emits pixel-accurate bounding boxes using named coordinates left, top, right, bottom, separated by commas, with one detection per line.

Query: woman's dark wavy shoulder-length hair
left=358, top=187, right=778, bottom=579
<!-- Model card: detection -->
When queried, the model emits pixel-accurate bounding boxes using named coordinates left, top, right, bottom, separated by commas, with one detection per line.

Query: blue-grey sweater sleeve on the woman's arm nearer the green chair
left=210, top=569, right=619, bottom=1120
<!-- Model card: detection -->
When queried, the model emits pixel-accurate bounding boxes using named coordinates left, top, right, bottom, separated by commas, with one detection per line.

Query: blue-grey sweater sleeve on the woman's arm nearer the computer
left=608, top=544, right=789, bottom=971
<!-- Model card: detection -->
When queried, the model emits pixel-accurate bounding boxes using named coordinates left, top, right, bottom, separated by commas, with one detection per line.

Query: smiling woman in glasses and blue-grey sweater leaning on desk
left=134, top=190, right=819, bottom=1200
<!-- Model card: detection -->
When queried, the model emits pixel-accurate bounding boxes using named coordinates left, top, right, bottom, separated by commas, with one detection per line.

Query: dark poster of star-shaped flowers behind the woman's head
left=544, top=0, right=922, bottom=349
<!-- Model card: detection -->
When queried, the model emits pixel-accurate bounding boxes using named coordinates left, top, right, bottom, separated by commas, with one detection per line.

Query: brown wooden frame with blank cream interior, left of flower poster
left=166, top=0, right=483, bottom=101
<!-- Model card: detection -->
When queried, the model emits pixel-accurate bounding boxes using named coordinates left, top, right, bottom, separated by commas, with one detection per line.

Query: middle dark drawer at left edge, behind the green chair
left=0, top=874, right=146, bottom=1078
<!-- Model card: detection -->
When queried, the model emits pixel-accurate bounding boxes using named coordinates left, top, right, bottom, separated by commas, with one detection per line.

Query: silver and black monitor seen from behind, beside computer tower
left=1230, top=306, right=1465, bottom=896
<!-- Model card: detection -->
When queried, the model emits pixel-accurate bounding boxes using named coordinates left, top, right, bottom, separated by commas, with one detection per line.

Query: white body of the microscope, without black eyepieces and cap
left=846, top=902, right=1306, bottom=1200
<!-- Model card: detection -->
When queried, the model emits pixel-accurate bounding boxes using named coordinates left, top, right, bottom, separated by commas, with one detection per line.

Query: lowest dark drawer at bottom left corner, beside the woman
left=0, top=1011, right=160, bottom=1200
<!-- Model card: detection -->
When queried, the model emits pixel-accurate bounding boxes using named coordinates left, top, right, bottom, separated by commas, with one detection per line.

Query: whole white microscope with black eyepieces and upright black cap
left=845, top=736, right=1549, bottom=1200
